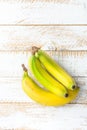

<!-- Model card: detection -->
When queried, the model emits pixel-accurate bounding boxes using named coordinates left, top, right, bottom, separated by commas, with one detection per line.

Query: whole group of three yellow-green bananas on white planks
left=22, top=46, right=79, bottom=106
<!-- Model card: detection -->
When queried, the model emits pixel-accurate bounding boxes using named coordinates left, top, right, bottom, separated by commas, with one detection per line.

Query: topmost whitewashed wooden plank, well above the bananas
left=0, top=0, right=87, bottom=25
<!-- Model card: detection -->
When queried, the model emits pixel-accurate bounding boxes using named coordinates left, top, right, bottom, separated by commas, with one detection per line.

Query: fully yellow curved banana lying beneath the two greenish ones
left=22, top=65, right=79, bottom=106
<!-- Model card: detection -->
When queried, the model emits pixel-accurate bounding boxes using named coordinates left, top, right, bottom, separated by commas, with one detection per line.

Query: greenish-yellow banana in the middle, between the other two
left=28, top=55, right=68, bottom=97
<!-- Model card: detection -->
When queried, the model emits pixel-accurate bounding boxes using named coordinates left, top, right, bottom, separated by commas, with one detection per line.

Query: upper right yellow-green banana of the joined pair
left=33, top=47, right=76, bottom=90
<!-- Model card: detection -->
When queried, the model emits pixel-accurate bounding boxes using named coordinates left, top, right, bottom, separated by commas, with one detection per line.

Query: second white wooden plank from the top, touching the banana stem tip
left=0, top=26, right=87, bottom=51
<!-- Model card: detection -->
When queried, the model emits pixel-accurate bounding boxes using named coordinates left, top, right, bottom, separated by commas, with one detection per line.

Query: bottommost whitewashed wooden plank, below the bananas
left=0, top=103, right=87, bottom=130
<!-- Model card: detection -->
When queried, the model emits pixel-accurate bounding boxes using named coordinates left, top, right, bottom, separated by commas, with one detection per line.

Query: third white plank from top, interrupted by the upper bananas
left=0, top=51, right=87, bottom=77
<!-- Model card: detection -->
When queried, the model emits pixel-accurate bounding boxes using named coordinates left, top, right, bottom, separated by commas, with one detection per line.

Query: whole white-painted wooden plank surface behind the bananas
left=0, top=0, right=87, bottom=130
